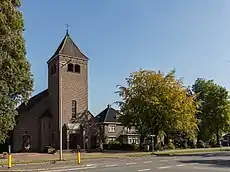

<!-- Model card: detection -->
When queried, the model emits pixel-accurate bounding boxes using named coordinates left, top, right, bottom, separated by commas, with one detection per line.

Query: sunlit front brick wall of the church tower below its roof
left=60, top=56, right=88, bottom=123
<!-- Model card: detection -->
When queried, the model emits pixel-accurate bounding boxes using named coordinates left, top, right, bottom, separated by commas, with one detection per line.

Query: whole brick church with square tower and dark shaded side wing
left=12, top=31, right=99, bottom=152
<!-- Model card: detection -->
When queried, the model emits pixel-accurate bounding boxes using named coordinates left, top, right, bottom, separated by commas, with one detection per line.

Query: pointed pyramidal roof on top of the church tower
left=48, top=32, right=88, bottom=62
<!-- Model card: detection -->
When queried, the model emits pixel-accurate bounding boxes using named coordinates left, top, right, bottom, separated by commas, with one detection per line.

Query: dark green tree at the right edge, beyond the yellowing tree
left=192, top=78, right=230, bottom=143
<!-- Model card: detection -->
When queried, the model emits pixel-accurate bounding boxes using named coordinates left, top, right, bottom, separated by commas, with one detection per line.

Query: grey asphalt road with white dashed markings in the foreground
left=0, top=152, right=230, bottom=172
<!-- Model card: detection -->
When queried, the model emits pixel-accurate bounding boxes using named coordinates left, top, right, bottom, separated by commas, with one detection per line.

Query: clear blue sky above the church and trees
left=21, top=0, right=230, bottom=115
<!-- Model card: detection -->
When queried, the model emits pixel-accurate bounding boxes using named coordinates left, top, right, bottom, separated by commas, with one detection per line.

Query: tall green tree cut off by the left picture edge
left=0, top=0, right=33, bottom=143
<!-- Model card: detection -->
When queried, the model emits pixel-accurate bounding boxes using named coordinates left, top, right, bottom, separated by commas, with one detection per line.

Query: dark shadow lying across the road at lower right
left=180, top=159, right=230, bottom=168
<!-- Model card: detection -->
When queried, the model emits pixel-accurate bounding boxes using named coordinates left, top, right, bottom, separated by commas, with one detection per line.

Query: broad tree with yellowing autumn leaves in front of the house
left=117, top=70, right=198, bottom=148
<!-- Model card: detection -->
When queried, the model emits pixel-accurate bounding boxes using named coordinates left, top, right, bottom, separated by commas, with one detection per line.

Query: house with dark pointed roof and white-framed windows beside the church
left=95, top=105, right=139, bottom=144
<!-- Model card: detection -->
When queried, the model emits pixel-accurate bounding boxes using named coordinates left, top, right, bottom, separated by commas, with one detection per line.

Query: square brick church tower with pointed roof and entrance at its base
left=47, top=31, right=88, bottom=149
